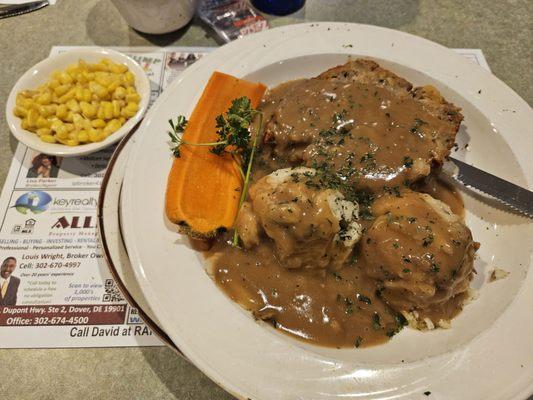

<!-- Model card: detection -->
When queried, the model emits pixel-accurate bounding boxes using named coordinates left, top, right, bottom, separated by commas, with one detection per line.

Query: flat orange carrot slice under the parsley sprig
left=165, top=72, right=266, bottom=238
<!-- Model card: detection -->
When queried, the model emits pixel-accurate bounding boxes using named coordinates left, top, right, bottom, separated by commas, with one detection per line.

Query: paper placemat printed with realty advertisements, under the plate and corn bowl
left=0, top=47, right=488, bottom=348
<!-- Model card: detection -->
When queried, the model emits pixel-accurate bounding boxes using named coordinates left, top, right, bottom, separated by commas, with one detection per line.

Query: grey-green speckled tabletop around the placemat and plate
left=0, top=0, right=533, bottom=399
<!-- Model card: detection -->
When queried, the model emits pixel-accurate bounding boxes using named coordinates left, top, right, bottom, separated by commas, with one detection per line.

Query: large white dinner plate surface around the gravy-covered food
left=122, top=23, right=533, bottom=400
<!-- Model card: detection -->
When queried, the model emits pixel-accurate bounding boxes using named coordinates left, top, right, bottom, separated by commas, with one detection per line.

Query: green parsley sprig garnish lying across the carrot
left=168, top=97, right=263, bottom=246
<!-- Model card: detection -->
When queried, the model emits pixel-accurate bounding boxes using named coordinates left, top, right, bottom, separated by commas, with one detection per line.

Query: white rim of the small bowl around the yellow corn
left=6, top=48, right=150, bottom=157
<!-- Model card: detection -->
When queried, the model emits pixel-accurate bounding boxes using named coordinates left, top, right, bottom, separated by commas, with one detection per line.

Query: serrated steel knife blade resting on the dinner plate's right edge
left=449, top=157, right=533, bottom=218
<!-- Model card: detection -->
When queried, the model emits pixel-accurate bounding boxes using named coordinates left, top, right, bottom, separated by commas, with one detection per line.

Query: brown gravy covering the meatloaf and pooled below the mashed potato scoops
left=205, top=73, right=470, bottom=348
